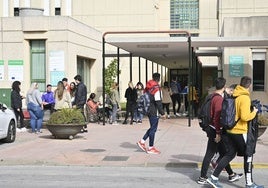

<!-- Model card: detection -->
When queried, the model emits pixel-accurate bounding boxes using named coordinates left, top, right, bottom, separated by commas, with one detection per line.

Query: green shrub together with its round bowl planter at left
left=46, top=108, right=86, bottom=139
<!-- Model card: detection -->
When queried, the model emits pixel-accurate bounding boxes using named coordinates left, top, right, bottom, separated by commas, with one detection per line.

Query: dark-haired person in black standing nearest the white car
left=11, top=81, right=26, bottom=131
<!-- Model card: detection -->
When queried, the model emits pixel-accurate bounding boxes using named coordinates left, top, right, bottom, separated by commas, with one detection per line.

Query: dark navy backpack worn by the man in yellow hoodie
left=220, top=94, right=240, bottom=130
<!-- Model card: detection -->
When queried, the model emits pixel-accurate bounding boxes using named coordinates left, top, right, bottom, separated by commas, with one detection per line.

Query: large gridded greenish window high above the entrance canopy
left=170, top=0, right=199, bottom=29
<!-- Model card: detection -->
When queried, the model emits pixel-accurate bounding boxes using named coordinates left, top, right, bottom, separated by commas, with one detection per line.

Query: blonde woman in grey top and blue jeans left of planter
left=26, top=82, right=44, bottom=134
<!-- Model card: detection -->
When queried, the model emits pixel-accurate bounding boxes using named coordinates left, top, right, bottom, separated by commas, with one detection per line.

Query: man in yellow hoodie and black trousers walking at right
left=207, top=76, right=264, bottom=188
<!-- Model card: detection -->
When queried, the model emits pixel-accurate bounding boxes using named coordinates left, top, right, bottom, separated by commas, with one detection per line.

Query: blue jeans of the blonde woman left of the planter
left=27, top=102, right=44, bottom=132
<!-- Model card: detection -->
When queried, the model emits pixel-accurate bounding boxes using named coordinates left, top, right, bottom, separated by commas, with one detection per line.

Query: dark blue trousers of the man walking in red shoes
left=143, top=116, right=159, bottom=147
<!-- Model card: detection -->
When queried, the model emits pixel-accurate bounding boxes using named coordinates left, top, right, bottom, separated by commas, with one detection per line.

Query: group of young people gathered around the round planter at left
left=11, top=75, right=87, bottom=133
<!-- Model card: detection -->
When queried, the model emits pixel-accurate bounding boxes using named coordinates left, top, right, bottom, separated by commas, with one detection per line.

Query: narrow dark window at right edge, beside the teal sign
left=252, top=49, right=266, bottom=91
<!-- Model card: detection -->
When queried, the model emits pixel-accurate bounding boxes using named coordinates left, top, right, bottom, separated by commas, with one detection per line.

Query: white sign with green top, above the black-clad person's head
left=8, top=60, right=23, bottom=81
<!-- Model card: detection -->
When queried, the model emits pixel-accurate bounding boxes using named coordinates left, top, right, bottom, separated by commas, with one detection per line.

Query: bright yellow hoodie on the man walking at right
left=228, top=85, right=256, bottom=134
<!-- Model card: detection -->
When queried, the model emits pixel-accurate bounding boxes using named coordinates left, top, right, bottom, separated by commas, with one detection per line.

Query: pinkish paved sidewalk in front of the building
left=0, top=118, right=268, bottom=168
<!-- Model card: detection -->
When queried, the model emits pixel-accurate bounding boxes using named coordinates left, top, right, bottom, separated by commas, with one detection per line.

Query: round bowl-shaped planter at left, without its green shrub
left=46, top=124, right=85, bottom=139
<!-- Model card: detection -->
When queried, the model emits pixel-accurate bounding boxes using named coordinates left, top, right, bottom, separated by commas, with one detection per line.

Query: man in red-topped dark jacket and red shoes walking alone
left=137, top=73, right=166, bottom=154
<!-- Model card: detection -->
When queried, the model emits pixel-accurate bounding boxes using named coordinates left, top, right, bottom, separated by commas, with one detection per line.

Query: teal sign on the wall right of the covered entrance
left=229, top=56, right=244, bottom=77
